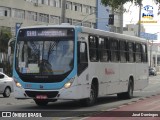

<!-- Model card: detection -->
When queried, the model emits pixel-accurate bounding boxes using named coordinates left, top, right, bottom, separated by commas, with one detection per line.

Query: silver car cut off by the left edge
left=0, top=72, right=13, bottom=97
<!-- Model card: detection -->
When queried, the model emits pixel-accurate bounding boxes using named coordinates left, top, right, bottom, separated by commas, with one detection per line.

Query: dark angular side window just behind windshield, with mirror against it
left=78, top=41, right=88, bottom=75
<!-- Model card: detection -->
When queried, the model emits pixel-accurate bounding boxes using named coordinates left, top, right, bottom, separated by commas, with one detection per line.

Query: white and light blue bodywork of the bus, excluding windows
left=13, top=25, right=148, bottom=100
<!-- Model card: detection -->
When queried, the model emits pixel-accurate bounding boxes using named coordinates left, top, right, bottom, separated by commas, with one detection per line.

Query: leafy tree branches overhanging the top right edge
left=101, top=0, right=160, bottom=9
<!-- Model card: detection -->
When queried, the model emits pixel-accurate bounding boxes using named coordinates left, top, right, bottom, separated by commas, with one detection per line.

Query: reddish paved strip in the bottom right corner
left=86, top=95, right=160, bottom=120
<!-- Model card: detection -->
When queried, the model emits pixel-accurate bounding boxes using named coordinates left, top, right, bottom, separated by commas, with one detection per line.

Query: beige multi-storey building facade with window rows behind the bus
left=0, top=0, right=96, bottom=35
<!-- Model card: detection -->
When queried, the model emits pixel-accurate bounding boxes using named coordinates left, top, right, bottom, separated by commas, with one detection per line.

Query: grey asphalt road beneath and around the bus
left=0, top=75, right=160, bottom=120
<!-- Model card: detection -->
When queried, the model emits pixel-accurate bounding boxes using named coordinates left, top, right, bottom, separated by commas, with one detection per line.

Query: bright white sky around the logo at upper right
left=123, top=0, right=160, bottom=41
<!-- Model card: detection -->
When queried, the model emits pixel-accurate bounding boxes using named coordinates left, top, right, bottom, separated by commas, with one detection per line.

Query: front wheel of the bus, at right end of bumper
left=80, top=84, right=97, bottom=106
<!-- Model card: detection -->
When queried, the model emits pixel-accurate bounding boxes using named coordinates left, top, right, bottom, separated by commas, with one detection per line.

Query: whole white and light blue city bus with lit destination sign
left=13, top=24, right=149, bottom=106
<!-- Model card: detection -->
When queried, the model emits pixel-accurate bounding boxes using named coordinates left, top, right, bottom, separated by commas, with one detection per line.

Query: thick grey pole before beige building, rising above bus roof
left=61, top=0, right=66, bottom=23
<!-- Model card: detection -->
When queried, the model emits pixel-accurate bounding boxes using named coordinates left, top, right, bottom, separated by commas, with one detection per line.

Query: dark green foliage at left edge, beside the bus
left=0, top=28, right=12, bottom=53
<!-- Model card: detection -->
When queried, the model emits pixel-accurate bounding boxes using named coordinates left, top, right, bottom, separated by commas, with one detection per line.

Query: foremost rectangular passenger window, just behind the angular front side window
left=89, top=36, right=99, bottom=62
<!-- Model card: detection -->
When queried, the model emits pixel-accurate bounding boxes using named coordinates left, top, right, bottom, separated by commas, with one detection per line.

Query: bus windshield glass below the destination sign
left=16, top=28, right=74, bottom=75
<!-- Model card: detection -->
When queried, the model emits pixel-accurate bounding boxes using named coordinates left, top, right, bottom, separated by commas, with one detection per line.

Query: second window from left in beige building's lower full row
left=12, top=9, right=24, bottom=19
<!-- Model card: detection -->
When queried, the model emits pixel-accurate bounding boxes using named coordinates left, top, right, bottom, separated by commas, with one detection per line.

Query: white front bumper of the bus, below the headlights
left=14, top=85, right=90, bottom=100
